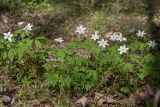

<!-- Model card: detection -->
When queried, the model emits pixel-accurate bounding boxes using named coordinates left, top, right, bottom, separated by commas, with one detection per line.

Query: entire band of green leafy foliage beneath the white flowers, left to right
left=0, top=25, right=160, bottom=93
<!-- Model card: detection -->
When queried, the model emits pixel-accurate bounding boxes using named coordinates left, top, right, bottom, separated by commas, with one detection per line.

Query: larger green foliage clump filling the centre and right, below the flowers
left=45, top=38, right=159, bottom=92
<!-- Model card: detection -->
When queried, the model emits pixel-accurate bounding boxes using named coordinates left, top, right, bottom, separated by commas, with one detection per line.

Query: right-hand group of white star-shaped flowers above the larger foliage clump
left=75, top=25, right=157, bottom=54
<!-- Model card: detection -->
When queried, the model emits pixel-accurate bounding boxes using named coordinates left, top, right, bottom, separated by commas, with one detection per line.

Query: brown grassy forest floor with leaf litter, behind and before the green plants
left=0, top=2, right=160, bottom=107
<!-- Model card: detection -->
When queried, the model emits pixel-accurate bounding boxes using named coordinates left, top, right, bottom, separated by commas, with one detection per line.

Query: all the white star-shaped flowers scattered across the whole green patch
left=3, top=22, right=157, bottom=54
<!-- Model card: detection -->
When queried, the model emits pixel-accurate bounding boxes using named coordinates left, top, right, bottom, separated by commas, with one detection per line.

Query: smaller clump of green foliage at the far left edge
left=0, top=30, right=46, bottom=80
